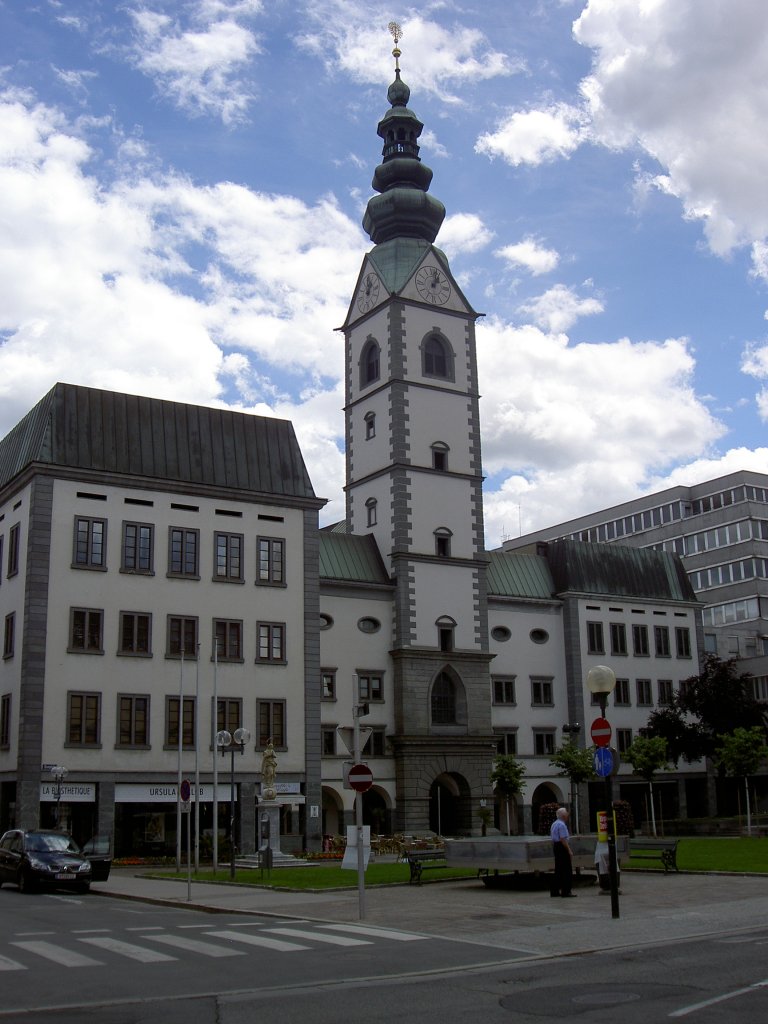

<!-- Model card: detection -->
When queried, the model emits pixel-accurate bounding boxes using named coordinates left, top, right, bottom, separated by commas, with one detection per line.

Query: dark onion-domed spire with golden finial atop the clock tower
left=362, top=22, right=445, bottom=245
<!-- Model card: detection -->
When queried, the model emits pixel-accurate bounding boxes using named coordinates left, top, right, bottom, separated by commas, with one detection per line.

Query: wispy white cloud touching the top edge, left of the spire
left=123, top=0, right=261, bottom=125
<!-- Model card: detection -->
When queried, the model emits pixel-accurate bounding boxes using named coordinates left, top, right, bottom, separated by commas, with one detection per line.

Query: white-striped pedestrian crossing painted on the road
left=0, top=921, right=426, bottom=972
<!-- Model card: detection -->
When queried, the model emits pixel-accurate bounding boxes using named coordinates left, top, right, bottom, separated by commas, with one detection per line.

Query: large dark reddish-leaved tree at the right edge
left=640, top=654, right=765, bottom=765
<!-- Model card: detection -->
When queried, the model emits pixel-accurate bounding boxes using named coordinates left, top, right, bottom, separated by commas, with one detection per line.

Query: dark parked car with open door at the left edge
left=0, top=828, right=112, bottom=892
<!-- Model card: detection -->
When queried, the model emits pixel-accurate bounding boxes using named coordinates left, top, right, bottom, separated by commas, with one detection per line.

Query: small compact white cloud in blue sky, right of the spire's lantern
left=475, top=103, right=587, bottom=167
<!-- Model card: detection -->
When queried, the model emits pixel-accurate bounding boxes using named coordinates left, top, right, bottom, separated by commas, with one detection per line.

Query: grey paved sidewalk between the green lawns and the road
left=92, top=868, right=768, bottom=959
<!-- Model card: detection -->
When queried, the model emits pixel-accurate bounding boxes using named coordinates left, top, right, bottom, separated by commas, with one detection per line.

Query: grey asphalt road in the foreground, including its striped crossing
left=0, top=888, right=768, bottom=1024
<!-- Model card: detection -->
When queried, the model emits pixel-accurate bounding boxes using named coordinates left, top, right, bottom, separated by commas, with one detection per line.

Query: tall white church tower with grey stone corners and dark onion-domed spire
left=343, top=25, right=496, bottom=835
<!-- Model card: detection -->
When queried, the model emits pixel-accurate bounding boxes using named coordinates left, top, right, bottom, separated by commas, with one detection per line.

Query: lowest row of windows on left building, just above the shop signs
left=0, top=690, right=287, bottom=750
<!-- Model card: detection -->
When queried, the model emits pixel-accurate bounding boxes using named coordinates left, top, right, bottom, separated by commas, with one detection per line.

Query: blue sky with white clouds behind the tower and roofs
left=0, top=0, right=768, bottom=545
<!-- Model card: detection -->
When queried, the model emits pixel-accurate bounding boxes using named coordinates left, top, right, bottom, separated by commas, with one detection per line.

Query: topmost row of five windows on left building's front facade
left=72, top=516, right=286, bottom=587
